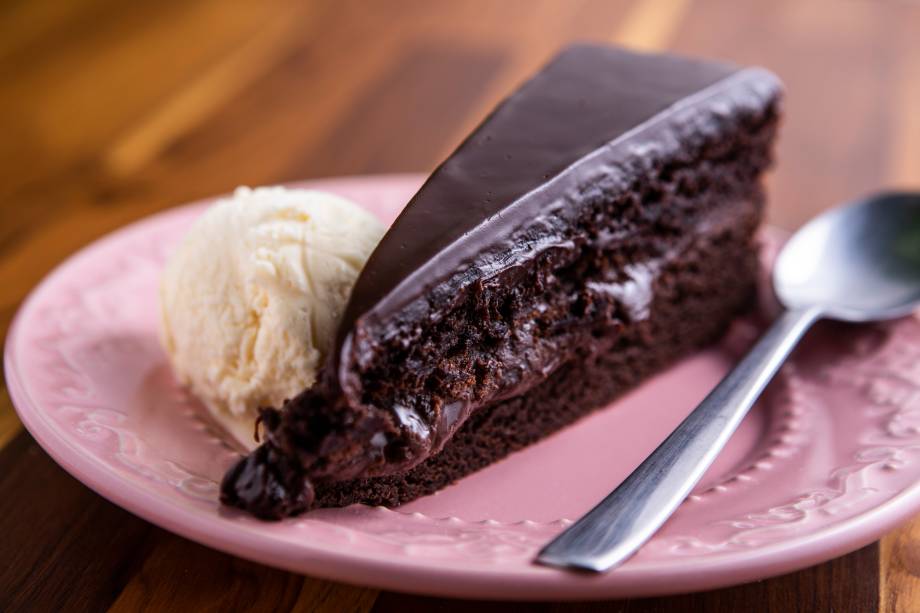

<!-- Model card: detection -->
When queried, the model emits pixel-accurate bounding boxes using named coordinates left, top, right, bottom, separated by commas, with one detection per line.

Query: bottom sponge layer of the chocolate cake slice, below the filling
left=316, top=208, right=759, bottom=507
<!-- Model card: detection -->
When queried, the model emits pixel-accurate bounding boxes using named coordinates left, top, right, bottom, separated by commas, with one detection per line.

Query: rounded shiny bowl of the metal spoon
left=773, top=193, right=920, bottom=322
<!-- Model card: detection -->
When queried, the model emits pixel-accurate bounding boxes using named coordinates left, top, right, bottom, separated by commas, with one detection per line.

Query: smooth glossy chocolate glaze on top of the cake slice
left=341, top=45, right=740, bottom=326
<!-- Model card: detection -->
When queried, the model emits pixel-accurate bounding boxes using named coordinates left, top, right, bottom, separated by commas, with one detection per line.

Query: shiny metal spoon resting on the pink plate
left=537, top=193, right=920, bottom=572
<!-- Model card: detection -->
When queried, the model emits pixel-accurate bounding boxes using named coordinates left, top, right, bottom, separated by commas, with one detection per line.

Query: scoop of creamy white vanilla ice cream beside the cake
left=160, top=187, right=385, bottom=448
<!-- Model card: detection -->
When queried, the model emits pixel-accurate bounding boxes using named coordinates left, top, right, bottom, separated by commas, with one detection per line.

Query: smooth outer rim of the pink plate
left=4, top=173, right=920, bottom=600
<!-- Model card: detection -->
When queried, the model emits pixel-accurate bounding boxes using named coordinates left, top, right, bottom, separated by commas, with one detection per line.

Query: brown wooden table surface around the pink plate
left=0, top=0, right=920, bottom=613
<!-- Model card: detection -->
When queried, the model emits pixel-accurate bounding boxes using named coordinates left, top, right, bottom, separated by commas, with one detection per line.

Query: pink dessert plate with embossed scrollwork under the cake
left=5, top=176, right=920, bottom=599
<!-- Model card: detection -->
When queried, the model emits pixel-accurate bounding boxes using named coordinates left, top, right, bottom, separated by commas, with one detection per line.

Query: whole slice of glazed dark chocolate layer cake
left=221, top=45, right=781, bottom=518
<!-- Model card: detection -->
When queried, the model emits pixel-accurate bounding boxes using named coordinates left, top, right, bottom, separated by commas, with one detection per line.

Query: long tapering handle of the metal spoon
left=537, top=308, right=821, bottom=572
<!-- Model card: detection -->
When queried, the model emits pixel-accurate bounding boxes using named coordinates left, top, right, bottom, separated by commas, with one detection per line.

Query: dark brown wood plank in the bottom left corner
left=0, top=432, right=158, bottom=612
